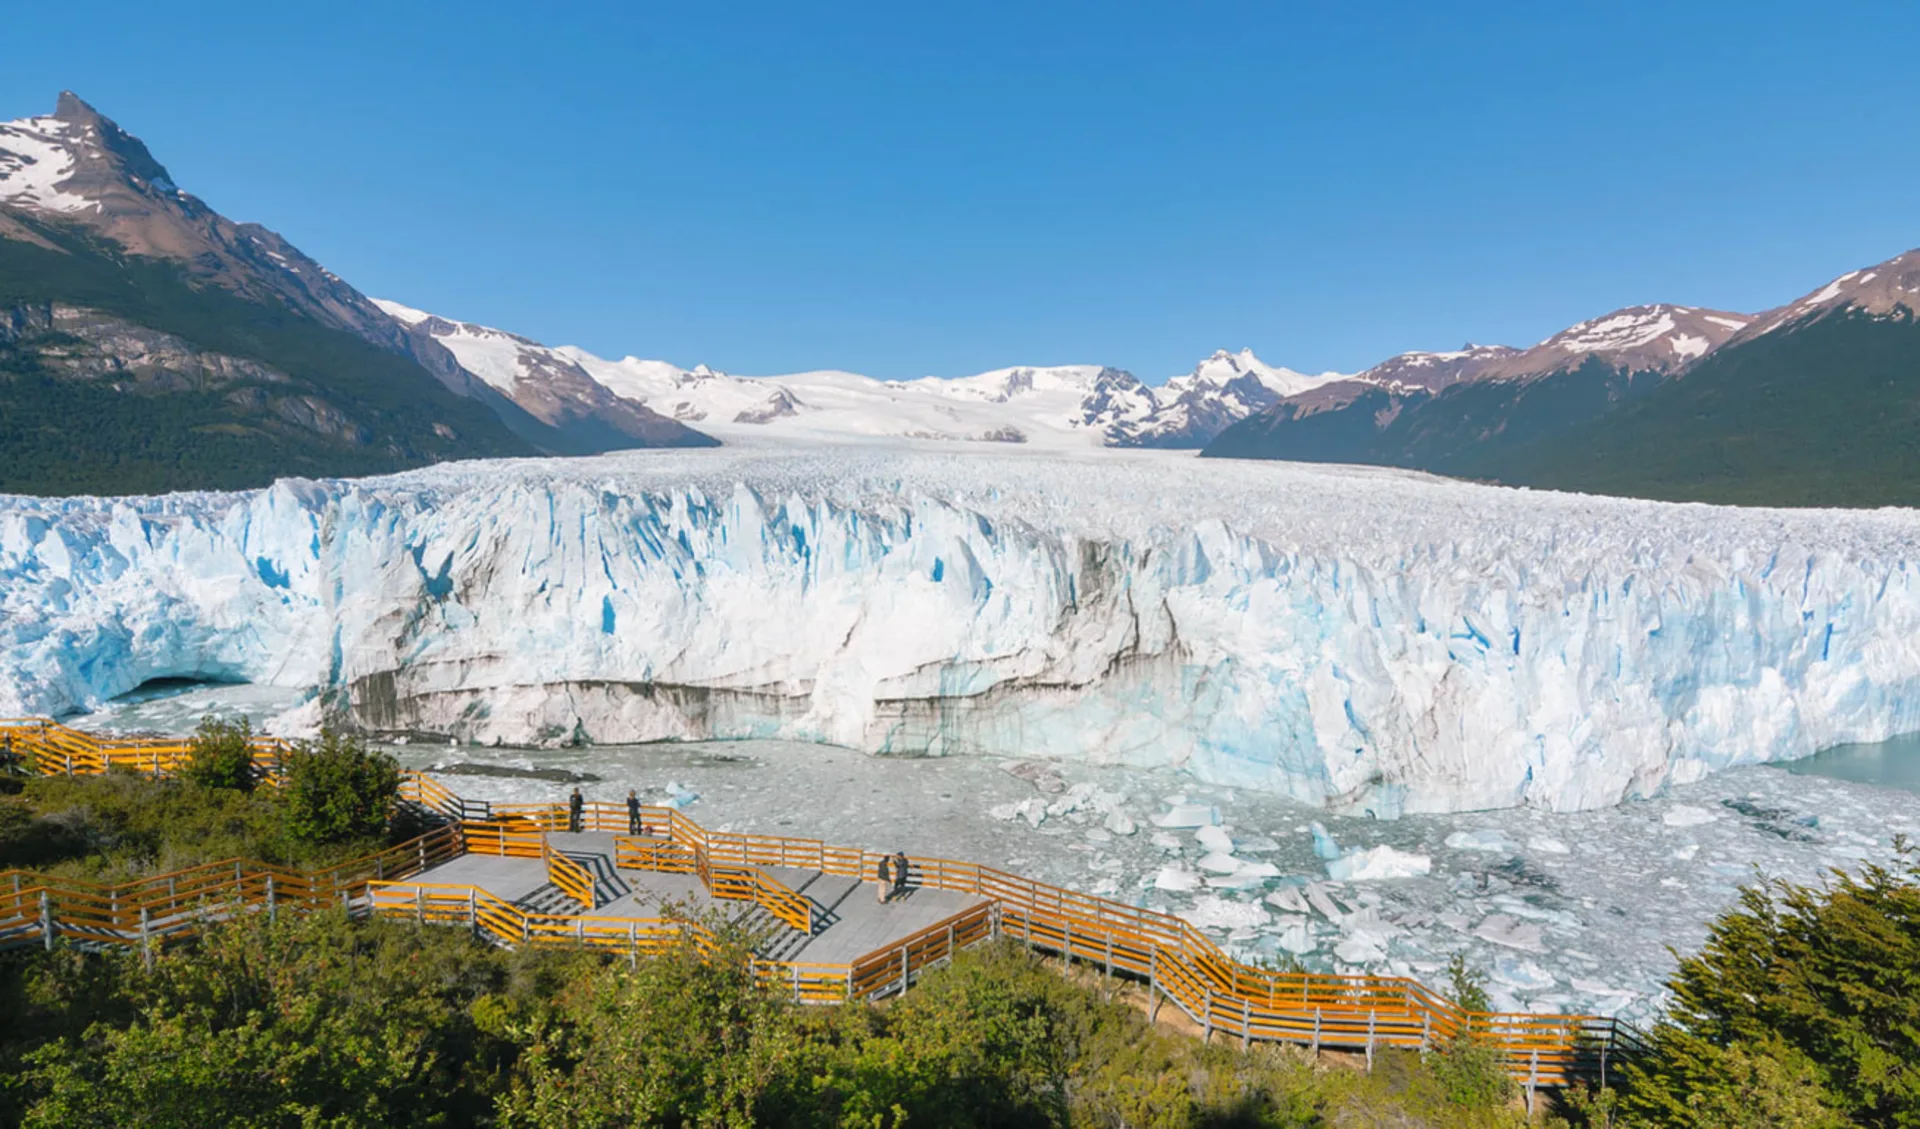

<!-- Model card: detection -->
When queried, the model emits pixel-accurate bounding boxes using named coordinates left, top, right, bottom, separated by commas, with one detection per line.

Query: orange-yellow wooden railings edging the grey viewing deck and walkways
left=0, top=718, right=1640, bottom=1085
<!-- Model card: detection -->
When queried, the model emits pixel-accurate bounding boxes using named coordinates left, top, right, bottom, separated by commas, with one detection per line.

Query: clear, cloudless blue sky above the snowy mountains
left=0, top=0, right=1920, bottom=382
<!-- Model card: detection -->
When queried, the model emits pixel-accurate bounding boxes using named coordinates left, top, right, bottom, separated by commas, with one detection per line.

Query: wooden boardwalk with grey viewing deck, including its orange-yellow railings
left=0, top=718, right=1644, bottom=1091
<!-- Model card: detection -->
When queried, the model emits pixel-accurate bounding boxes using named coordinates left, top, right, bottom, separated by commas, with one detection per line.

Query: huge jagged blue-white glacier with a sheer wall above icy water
left=0, top=445, right=1920, bottom=818
